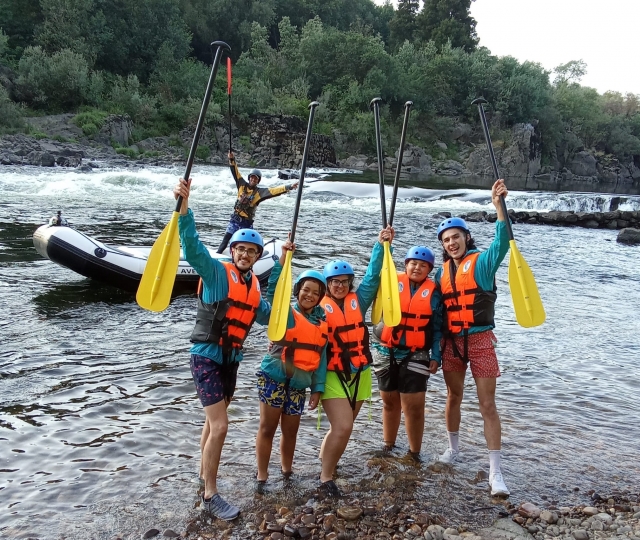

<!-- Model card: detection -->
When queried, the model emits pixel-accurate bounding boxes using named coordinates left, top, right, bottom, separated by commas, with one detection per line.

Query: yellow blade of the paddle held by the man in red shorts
left=509, top=240, right=546, bottom=328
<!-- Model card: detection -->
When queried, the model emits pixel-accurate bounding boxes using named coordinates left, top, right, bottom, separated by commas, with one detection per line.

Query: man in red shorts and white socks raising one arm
left=435, top=180, right=509, bottom=496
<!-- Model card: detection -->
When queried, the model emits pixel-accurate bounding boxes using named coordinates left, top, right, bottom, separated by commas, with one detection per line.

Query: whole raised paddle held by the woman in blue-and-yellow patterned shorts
left=267, top=101, right=320, bottom=341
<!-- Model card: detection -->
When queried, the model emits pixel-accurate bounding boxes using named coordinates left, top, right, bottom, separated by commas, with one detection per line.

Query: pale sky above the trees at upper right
left=374, top=0, right=640, bottom=94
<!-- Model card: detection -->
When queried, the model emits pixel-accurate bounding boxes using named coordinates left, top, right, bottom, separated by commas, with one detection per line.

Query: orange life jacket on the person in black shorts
left=381, top=272, right=436, bottom=352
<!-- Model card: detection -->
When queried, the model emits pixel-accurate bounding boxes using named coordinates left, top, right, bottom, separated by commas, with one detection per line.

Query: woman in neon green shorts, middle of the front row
left=320, top=227, right=394, bottom=497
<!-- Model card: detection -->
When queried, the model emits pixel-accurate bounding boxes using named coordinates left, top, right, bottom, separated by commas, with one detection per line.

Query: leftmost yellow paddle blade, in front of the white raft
left=136, top=212, right=180, bottom=311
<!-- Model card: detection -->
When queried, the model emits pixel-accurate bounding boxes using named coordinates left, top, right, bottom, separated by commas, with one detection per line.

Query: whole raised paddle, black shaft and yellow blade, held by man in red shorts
left=471, top=97, right=546, bottom=328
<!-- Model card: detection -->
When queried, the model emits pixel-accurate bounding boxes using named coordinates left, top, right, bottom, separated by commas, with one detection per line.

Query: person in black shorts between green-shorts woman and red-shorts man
left=374, top=246, right=442, bottom=461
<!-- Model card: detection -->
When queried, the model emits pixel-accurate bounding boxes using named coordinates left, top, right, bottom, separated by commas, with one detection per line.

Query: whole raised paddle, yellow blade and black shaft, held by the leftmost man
left=136, top=41, right=231, bottom=311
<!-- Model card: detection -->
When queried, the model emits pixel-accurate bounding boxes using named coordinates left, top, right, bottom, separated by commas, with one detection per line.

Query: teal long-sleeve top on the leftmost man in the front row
left=178, top=209, right=271, bottom=364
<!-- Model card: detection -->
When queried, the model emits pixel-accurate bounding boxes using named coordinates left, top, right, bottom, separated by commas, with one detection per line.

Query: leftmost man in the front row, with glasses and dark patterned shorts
left=173, top=179, right=271, bottom=521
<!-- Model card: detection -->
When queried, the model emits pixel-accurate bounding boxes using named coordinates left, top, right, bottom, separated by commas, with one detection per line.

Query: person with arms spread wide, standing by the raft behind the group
left=218, top=152, right=298, bottom=253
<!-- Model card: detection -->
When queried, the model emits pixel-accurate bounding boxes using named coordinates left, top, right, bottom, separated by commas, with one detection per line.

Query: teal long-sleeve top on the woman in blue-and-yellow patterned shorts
left=260, top=261, right=327, bottom=393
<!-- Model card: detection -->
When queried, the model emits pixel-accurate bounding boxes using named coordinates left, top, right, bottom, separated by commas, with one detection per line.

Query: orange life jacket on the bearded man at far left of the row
left=191, top=262, right=261, bottom=348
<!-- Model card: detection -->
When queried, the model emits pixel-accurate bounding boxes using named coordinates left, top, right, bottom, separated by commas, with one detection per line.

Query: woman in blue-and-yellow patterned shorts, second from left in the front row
left=256, top=241, right=327, bottom=491
